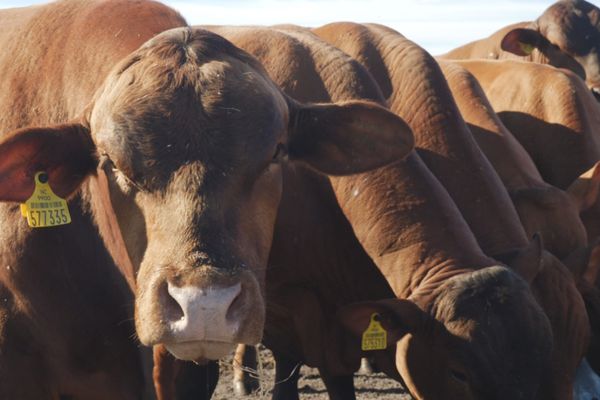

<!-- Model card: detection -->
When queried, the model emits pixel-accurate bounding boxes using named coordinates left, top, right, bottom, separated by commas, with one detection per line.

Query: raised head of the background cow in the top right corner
left=502, top=0, right=600, bottom=98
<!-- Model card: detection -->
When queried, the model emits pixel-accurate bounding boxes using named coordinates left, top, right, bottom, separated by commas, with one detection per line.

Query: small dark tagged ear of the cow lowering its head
left=338, top=299, right=431, bottom=347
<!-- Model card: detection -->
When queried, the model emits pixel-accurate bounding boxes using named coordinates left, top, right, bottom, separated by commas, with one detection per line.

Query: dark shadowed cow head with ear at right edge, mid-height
left=510, top=163, right=600, bottom=259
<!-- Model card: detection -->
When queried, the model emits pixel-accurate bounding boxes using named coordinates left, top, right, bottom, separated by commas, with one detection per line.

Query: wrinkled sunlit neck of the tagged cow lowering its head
left=331, top=153, right=494, bottom=298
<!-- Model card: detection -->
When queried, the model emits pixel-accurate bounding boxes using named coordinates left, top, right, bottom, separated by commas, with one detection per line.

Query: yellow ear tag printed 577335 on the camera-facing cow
left=21, top=172, right=71, bottom=228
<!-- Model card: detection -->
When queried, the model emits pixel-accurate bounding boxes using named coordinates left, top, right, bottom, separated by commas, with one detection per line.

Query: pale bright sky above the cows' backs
left=0, top=0, right=600, bottom=55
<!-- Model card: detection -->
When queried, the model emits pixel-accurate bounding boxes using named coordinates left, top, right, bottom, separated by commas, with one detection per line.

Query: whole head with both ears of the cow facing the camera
left=0, top=28, right=413, bottom=359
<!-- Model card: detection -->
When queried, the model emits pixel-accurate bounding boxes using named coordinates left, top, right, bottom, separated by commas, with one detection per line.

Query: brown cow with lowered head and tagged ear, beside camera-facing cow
left=211, top=27, right=564, bottom=399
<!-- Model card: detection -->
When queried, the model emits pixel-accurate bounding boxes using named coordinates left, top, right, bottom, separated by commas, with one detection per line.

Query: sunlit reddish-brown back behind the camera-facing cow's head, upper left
left=0, top=0, right=185, bottom=133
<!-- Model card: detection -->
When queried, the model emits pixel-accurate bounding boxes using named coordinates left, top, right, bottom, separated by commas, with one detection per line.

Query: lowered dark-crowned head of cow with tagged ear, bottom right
left=340, top=266, right=552, bottom=400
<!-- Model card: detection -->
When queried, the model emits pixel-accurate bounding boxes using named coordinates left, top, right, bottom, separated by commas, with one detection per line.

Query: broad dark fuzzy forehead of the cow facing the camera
left=91, top=29, right=288, bottom=189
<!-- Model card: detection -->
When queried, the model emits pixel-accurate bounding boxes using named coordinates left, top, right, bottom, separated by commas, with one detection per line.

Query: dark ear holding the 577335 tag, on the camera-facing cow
left=0, top=123, right=97, bottom=202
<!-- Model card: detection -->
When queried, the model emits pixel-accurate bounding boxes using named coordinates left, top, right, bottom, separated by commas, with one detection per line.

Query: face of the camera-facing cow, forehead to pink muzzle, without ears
left=90, top=32, right=289, bottom=358
